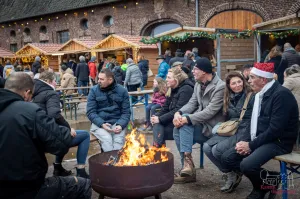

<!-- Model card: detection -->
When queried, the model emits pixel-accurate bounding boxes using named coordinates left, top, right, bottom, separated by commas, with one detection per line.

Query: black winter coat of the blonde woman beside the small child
left=156, top=79, right=194, bottom=125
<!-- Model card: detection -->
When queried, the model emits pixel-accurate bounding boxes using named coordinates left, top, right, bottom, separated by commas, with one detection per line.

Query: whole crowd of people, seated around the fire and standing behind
left=0, top=43, right=300, bottom=199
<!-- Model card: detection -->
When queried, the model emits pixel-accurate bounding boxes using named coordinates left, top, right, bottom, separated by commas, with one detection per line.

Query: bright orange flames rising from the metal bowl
left=114, top=129, right=169, bottom=166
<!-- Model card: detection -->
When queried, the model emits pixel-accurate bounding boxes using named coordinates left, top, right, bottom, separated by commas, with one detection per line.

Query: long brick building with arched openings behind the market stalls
left=0, top=0, right=300, bottom=51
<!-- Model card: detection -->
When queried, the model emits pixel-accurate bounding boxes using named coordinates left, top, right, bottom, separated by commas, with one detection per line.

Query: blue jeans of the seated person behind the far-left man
left=55, top=130, right=90, bottom=165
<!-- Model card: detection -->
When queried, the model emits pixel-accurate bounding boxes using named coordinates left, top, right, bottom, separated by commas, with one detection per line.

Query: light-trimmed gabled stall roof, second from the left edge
left=16, top=43, right=62, bottom=56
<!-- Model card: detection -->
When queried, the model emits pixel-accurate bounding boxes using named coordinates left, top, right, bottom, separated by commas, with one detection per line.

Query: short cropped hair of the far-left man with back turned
left=4, top=72, right=34, bottom=93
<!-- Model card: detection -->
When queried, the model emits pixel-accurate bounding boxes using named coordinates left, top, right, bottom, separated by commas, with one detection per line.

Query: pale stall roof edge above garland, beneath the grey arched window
left=155, top=26, right=216, bottom=37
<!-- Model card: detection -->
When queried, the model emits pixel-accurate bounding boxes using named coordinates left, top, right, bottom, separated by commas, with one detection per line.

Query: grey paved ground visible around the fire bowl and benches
left=47, top=104, right=300, bottom=199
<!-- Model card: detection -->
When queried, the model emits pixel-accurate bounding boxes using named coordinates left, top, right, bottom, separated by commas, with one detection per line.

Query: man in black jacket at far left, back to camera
left=0, top=72, right=91, bottom=199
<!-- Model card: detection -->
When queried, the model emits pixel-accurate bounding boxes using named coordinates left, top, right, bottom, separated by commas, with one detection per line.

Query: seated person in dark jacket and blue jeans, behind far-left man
left=33, top=71, right=90, bottom=178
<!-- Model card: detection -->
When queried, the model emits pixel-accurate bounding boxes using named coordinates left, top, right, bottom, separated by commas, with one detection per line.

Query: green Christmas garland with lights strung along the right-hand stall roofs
left=141, top=29, right=300, bottom=44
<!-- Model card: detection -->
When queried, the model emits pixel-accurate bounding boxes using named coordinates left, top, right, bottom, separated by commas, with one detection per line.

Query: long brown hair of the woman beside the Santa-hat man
left=223, top=71, right=251, bottom=115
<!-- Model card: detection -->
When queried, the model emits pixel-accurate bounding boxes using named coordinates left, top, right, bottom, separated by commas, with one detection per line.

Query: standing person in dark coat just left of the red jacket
left=75, top=56, right=90, bottom=96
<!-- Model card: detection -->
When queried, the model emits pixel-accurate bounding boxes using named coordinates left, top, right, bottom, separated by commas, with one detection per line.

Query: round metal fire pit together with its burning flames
left=89, top=131, right=174, bottom=199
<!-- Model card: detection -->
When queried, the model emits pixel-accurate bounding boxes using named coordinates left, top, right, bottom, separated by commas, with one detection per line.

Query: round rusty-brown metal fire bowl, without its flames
left=89, top=151, right=174, bottom=198
